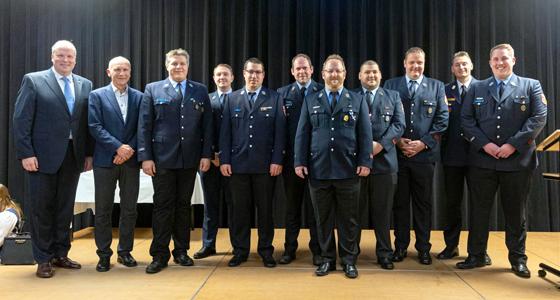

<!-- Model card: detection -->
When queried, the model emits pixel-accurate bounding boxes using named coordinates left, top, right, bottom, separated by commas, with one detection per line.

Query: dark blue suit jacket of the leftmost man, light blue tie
left=14, top=69, right=93, bottom=174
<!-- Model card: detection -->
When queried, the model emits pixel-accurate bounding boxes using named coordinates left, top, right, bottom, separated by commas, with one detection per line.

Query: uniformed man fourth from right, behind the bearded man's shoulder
left=356, top=60, right=406, bottom=270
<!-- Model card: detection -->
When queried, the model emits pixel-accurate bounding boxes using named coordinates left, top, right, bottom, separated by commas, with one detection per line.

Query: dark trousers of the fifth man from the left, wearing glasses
left=229, top=174, right=276, bottom=257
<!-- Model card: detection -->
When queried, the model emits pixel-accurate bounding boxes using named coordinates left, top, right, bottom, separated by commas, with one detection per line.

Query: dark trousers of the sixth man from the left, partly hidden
left=282, top=168, right=321, bottom=256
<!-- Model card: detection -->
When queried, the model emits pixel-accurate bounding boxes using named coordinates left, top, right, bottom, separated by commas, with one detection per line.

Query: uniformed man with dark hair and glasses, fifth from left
left=220, top=58, right=286, bottom=268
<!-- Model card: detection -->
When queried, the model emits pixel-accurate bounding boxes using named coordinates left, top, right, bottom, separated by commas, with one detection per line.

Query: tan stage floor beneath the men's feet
left=0, top=229, right=560, bottom=300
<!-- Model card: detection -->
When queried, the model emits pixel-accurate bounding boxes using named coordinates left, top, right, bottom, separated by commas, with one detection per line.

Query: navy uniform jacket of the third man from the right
left=383, top=75, right=449, bottom=163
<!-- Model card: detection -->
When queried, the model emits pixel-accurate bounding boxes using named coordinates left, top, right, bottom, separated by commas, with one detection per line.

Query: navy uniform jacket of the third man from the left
left=138, top=79, right=212, bottom=169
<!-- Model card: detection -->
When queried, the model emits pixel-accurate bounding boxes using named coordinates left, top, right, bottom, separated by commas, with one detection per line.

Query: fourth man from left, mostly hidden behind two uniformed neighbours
left=194, top=64, right=233, bottom=259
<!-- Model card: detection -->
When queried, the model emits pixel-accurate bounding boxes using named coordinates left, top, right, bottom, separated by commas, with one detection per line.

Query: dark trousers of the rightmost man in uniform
left=467, top=167, right=533, bottom=264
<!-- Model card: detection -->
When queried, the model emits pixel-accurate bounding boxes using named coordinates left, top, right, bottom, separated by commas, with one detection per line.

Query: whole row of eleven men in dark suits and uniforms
left=14, top=41, right=546, bottom=278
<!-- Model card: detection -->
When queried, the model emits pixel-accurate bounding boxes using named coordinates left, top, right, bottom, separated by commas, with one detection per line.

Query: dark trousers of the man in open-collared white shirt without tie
left=93, top=165, right=140, bottom=257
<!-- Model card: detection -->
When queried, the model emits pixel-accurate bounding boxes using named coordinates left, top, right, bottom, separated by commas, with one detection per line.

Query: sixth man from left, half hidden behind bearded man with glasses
left=278, top=53, right=324, bottom=266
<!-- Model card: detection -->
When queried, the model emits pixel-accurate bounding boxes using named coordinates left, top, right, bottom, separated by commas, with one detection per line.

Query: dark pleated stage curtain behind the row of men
left=0, top=0, right=560, bottom=231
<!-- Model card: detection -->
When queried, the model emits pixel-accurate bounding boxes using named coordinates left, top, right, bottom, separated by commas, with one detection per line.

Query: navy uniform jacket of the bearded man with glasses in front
left=294, top=89, right=372, bottom=180
